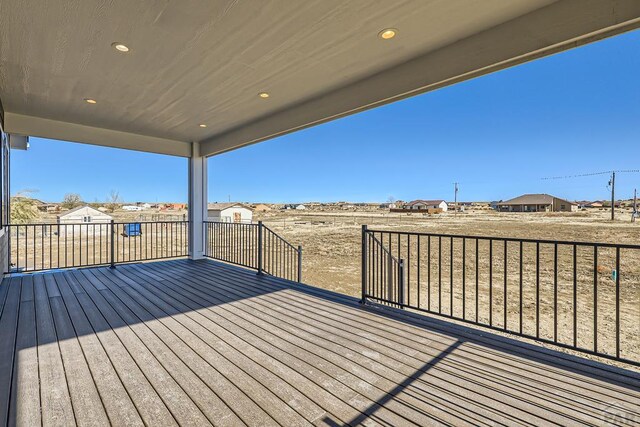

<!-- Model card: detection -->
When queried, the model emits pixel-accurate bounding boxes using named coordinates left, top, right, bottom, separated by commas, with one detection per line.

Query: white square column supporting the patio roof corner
left=189, top=142, right=207, bottom=259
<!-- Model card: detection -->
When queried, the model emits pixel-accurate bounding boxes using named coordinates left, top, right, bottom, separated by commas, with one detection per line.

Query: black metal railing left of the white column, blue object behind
left=8, top=221, right=189, bottom=272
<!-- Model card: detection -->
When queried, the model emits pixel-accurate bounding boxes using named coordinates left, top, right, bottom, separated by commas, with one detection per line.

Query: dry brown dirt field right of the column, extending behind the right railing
left=258, top=210, right=640, bottom=366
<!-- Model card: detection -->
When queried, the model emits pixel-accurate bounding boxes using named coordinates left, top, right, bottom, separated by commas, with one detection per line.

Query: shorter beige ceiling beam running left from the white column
left=5, top=112, right=191, bottom=157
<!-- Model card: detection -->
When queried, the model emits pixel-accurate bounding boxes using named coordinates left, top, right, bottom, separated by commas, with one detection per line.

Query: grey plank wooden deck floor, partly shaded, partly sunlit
left=0, top=260, right=640, bottom=426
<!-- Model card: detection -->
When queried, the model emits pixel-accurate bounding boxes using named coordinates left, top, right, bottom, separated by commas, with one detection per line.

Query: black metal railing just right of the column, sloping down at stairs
left=204, top=221, right=302, bottom=282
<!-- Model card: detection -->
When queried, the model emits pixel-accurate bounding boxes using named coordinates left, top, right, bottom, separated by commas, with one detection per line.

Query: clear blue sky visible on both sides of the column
left=12, top=31, right=640, bottom=202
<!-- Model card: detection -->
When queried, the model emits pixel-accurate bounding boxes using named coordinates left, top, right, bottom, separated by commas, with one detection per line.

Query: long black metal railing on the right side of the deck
left=362, top=226, right=640, bottom=365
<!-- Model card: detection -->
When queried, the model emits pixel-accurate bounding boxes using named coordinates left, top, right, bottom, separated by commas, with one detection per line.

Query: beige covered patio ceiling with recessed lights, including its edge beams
left=0, top=0, right=640, bottom=156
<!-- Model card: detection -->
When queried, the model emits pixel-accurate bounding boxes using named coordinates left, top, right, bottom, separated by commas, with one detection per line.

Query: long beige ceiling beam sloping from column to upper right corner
left=201, top=0, right=640, bottom=156
